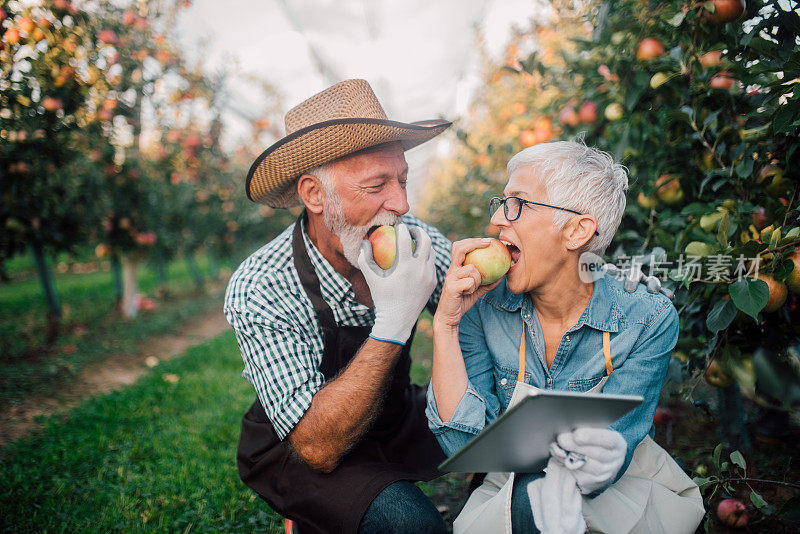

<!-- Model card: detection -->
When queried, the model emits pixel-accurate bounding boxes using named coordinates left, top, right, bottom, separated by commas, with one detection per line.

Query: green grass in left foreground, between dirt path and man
left=0, top=332, right=281, bottom=533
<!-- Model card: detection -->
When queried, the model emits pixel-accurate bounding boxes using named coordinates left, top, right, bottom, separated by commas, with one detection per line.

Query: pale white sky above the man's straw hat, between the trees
left=176, top=0, right=552, bottom=206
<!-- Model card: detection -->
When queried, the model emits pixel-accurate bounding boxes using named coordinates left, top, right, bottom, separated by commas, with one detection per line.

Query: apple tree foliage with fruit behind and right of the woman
left=418, top=0, right=800, bottom=409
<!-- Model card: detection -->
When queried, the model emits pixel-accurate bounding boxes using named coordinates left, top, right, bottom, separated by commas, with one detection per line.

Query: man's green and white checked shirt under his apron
left=224, top=215, right=452, bottom=439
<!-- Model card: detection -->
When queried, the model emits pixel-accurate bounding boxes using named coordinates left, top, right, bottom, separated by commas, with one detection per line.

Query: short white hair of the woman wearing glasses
left=507, top=140, right=628, bottom=255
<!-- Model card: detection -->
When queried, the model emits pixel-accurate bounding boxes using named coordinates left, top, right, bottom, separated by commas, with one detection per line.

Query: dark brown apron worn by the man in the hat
left=237, top=216, right=445, bottom=534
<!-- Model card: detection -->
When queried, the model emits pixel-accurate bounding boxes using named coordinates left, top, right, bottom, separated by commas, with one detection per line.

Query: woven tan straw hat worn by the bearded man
left=245, top=80, right=451, bottom=208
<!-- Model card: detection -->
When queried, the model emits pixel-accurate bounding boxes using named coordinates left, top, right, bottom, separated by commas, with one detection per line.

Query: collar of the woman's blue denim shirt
left=484, top=276, right=625, bottom=332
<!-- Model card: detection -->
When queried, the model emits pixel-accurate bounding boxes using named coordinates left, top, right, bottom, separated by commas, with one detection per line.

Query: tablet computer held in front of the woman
left=439, top=391, right=644, bottom=473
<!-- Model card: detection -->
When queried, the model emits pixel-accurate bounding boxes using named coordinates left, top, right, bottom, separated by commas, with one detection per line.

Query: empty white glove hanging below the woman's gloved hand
left=528, top=458, right=586, bottom=534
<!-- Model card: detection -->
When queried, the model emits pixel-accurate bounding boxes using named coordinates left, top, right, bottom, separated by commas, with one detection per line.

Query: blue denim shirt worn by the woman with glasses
left=425, top=276, right=678, bottom=478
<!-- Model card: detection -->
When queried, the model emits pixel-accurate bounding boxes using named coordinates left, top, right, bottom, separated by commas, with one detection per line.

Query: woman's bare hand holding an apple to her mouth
left=433, top=237, right=502, bottom=328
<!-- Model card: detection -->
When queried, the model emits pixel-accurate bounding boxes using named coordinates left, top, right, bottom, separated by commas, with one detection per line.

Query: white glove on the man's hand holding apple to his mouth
left=358, top=223, right=436, bottom=345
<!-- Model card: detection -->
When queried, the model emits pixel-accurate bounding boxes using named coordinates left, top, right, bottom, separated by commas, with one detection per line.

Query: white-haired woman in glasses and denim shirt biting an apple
left=427, top=141, right=704, bottom=533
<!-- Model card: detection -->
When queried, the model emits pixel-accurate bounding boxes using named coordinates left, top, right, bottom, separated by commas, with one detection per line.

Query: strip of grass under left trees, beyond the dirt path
left=0, top=255, right=228, bottom=408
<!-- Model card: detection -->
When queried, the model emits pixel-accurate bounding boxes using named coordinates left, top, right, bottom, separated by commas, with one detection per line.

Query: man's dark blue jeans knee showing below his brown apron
left=358, top=480, right=446, bottom=534
